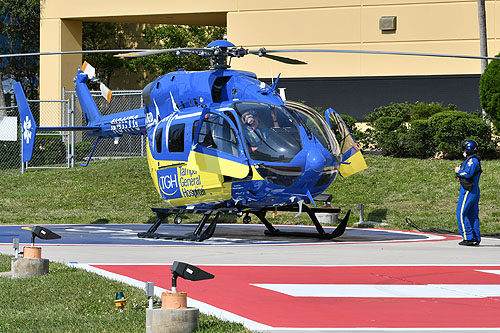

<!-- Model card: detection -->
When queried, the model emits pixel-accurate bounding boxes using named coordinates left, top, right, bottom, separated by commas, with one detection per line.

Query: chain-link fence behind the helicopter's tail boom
left=0, top=90, right=146, bottom=173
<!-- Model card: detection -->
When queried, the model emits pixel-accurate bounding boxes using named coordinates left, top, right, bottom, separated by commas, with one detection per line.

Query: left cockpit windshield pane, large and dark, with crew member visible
left=234, top=102, right=302, bottom=163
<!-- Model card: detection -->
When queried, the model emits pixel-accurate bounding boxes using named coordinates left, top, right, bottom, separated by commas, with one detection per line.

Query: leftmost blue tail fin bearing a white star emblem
left=14, top=82, right=36, bottom=162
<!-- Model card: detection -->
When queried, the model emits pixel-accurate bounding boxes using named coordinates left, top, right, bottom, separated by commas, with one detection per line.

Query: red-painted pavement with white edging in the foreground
left=74, top=264, right=500, bottom=330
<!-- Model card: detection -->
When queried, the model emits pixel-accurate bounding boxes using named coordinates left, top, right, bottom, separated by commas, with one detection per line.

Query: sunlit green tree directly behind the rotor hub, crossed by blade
left=126, top=25, right=226, bottom=81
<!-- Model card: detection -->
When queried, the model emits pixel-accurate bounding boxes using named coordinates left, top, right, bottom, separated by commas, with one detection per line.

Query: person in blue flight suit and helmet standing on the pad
left=455, top=140, right=482, bottom=246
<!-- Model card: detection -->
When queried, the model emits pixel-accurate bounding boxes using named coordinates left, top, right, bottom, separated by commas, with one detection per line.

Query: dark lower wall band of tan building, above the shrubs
left=265, top=74, right=481, bottom=120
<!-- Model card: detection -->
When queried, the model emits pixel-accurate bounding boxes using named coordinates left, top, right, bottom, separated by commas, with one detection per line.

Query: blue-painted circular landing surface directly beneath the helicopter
left=0, top=224, right=448, bottom=246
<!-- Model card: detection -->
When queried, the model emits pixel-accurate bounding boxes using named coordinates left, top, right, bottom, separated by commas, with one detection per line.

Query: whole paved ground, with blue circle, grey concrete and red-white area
left=0, top=224, right=500, bottom=332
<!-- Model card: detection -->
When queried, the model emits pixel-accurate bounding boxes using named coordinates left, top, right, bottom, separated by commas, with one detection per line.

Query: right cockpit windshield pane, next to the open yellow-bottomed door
left=286, top=101, right=340, bottom=156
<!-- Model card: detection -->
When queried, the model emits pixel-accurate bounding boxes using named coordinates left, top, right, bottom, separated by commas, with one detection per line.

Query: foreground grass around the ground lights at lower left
left=0, top=255, right=249, bottom=333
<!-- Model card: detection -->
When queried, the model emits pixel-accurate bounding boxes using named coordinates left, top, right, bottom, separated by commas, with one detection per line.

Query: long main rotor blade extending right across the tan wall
left=254, top=49, right=500, bottom=60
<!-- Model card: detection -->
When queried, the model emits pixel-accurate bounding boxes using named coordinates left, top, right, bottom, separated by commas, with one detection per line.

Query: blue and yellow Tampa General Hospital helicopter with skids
left=9, top=39, right=497, bottom=241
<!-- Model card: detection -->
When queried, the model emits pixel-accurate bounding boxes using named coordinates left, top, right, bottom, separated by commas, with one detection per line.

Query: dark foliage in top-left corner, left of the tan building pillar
left=0, top=0, right=40, bottom=98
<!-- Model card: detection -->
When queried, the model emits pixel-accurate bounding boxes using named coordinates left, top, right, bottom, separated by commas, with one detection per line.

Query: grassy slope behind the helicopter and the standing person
left=0, top=156, right=500, bottom=233
